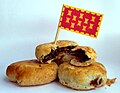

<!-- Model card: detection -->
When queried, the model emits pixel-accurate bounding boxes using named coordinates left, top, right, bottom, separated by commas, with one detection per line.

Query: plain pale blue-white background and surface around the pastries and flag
left=0, top=0, right=120, bottom=93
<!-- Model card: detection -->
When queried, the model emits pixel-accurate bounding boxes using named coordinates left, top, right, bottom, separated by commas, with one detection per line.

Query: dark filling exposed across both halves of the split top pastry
left=42, top=46, right=90, bottom=63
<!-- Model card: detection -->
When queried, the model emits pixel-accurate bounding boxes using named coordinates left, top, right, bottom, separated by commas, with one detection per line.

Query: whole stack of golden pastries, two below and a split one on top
left=6, top=40, right=107, bottom=90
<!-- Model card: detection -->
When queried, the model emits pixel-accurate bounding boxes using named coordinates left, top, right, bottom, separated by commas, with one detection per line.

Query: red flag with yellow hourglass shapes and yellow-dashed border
left=59, top=5, right=103, bottom=38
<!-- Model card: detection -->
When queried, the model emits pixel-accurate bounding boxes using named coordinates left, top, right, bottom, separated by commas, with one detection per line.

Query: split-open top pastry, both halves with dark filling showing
left=35, top=40, right=97, bottom=66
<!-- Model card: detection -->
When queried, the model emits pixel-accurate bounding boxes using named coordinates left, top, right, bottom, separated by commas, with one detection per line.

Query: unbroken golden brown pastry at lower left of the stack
left=6, top=60, right=58, bottom=86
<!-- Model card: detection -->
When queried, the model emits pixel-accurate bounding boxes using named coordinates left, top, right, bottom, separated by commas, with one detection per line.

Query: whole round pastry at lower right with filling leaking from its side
left=58, top=62, right=107, bottom=90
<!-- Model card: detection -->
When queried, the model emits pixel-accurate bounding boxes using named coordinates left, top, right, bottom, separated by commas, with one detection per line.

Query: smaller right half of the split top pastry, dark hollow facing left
left=70, top=46, right=97, bottom=66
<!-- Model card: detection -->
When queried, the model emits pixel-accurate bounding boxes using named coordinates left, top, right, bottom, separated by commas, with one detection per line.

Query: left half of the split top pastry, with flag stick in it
left=35, top=40, right=78, bottom=63
